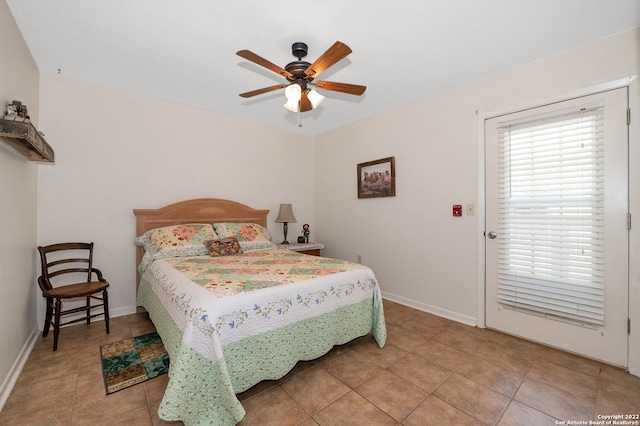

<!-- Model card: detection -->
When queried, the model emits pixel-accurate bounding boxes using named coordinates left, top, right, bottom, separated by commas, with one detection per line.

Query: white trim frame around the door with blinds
left=476, top=75, right=640, bottom=332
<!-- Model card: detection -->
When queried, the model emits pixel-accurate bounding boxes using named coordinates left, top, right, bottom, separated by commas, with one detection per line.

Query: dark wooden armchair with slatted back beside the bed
left=38, top=243, right=109, bottom=351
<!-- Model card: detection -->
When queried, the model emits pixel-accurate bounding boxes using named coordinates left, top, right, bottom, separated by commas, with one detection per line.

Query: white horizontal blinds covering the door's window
left=497, top=104, right=604, bottom=326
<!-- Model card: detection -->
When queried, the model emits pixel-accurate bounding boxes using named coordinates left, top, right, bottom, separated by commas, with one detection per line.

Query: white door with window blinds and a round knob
left=485, top=88, right=629, bottom=366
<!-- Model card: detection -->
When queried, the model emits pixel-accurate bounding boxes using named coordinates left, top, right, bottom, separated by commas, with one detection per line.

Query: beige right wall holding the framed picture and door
left=315, top=29, right=640, bottom=374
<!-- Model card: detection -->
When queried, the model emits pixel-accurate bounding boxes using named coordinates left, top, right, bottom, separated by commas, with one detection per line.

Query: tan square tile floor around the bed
left=0, top=301, right=640, bottom=426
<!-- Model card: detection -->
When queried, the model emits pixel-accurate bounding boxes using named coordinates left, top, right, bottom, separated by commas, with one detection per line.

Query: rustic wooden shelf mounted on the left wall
left=0, top=118, right=54, bottom=163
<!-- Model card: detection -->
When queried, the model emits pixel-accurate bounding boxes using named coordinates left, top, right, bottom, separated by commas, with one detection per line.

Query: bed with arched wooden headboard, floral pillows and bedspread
left=134, top=198, right=386, bottom=425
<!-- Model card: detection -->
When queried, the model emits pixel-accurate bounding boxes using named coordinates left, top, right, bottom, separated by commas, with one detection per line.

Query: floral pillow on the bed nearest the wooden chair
left=135, top=223, right=217, bottom=259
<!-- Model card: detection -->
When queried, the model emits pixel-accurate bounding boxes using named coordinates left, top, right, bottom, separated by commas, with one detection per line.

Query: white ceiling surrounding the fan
left=6, top=0, right=640, bottom=135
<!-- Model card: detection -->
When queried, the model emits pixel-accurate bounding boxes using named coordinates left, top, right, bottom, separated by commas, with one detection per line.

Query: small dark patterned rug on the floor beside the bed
left=100, top=331, right=169, bottom=395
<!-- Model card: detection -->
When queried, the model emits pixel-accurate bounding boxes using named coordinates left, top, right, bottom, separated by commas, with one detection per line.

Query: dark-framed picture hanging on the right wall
left=358, top=157, right=396, bottom=198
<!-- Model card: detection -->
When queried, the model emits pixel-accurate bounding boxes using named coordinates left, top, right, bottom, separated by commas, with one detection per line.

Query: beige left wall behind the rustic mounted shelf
left=0, top=0, right=40, bottom=407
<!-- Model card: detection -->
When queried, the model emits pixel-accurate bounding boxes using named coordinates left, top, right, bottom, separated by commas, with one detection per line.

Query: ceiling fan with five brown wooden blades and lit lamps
left=236, top=41, right=367, bottom=112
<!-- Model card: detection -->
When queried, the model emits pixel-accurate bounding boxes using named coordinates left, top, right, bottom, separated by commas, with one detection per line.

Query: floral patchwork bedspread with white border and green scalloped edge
left=138, top=249, right=386, bottom=425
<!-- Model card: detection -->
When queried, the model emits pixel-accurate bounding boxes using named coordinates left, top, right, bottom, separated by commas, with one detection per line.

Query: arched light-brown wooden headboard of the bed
left=133, top=198, right=269, bottom=293
